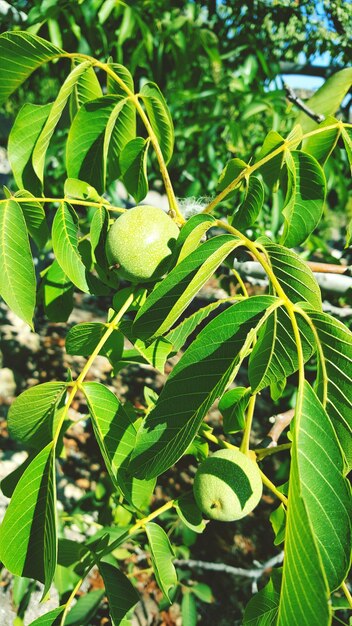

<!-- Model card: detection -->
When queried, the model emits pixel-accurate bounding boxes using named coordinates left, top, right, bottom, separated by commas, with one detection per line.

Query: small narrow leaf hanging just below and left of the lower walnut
left=145, top=522, right=177, bottom=603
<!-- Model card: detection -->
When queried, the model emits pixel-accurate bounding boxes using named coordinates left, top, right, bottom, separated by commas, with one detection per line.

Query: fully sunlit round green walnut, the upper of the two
left=106, top=205, right=179, bottom=283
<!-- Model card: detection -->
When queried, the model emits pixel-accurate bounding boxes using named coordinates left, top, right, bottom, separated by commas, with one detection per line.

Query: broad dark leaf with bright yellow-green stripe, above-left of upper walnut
left=66, top=95, right=136, bottom=193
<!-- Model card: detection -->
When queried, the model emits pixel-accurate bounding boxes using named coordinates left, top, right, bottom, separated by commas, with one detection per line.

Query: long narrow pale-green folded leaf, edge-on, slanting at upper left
left=32, top=61, right=92, bottom=182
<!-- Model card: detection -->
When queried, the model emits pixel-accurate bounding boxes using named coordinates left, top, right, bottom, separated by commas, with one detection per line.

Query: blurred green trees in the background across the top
left=0, top=0, right=352, bottom=239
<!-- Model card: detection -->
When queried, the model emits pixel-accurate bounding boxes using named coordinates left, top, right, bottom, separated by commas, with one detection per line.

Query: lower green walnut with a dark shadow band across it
left=193, top=449, right=263, bottom=522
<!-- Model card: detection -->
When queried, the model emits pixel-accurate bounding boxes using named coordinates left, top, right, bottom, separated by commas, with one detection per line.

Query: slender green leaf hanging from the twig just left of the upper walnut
left=52, top=202, right=89, bottom=293
